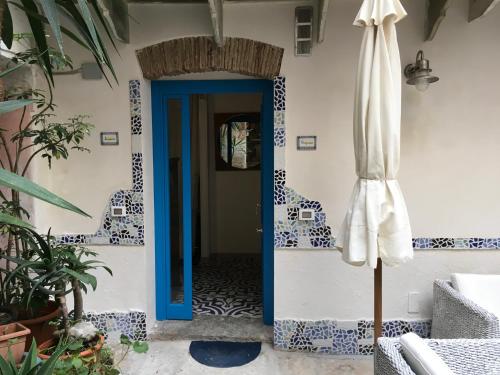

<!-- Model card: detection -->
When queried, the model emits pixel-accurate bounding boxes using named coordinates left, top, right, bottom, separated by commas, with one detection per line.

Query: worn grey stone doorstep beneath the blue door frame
left=149, top=315, right=273, bottom=343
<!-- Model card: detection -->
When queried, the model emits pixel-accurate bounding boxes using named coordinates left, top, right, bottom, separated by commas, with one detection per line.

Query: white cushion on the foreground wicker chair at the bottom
left=400, top=333, right=453, bottom=375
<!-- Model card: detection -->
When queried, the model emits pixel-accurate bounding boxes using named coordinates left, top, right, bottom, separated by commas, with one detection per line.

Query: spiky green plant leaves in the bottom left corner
left=0, top=339, right=66, bottom=375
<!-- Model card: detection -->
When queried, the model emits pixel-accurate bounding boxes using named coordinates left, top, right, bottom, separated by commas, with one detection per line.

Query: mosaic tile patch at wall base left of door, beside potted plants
left=83, top=311, right=147, bottom=341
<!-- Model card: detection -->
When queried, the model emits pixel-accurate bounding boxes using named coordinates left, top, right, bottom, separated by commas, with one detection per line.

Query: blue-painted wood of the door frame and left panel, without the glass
left=151, top=80, right=274, bottom=325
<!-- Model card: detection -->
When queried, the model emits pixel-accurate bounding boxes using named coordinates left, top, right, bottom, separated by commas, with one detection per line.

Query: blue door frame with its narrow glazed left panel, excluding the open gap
left=151, top=80, right=274, bottom=325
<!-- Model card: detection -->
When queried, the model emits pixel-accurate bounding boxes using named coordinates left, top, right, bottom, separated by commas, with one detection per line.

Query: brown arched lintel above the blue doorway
left=136, top=36, right=284, bottom=80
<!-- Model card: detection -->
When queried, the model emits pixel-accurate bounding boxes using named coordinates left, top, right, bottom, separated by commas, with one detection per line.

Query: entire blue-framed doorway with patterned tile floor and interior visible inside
left=152, top=80, right=274, bottom=325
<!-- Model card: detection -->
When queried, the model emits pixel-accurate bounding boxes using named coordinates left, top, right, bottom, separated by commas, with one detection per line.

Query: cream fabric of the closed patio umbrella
left=339, top=0, right=413, bottom=268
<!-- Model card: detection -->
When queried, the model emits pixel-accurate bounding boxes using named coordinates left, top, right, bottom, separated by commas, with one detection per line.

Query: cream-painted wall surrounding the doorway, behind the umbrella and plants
left=30, top=0, right=500, bottom=319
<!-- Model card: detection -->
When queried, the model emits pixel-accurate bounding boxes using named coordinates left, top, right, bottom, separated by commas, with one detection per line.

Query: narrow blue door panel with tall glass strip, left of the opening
left=153, top=94, right=193, bottom=320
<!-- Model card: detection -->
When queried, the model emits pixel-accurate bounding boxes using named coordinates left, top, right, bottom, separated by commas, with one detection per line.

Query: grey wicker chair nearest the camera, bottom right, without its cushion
left=375, top=338, right=500, bottom=375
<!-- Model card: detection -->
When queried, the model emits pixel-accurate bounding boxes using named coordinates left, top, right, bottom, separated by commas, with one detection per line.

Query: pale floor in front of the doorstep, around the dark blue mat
left=120, top=340, right=373, bottom=375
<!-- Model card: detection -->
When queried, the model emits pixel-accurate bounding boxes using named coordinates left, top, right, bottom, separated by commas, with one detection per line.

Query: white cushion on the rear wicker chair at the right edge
left=451, top=273, right=500, bottom=319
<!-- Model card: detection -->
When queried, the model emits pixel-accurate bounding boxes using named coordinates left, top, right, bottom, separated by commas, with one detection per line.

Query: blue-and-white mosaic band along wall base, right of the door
left=274, top=320, right=431, bottom=356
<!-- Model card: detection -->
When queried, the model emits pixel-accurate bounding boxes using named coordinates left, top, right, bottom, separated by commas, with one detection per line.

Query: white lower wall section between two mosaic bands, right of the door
left=274, top=250, right=500, bottom=320
